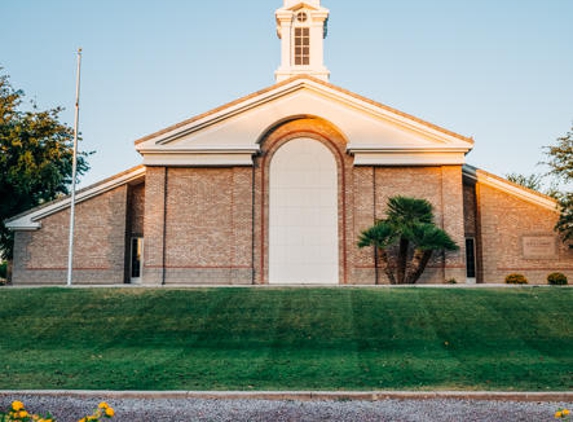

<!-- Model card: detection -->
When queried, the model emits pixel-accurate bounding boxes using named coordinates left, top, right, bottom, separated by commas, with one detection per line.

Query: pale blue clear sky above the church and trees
left=0, top=0, right=573, bottom=186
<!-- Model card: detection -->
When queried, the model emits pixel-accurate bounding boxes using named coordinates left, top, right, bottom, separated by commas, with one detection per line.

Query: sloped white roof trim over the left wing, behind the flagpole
left=6, top=166, right=145, bottom=231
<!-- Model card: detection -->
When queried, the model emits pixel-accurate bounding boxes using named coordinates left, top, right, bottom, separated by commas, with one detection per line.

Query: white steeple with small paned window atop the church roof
left=275, top=0, right=330, bottom=82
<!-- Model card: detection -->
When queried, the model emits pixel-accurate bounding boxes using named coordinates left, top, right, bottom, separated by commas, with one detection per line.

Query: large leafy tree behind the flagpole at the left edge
left=0, top=68, right=89, bottom=259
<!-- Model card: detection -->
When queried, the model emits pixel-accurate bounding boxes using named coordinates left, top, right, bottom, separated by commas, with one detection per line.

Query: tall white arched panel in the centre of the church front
left=269, top=138, right=338, bottom=284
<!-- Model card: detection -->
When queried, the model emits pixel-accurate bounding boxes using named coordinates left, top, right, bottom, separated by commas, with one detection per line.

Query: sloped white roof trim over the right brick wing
left=463, top=165, right=559, bottom=212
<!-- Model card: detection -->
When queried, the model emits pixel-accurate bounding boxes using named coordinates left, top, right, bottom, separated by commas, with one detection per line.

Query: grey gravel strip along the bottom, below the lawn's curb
left=0, top=395, right=573, bottom=422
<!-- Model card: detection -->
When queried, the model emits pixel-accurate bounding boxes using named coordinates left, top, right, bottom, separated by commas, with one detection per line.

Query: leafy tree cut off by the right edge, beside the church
left=546, top=123, right=573, bottom=248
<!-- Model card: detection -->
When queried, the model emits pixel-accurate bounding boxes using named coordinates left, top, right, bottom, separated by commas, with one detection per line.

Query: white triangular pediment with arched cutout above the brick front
left=136, top=77, right=473, bottom=166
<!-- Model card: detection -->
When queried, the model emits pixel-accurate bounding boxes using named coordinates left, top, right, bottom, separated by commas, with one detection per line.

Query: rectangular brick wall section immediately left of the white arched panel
left=160, top=167, right=252, bottom=284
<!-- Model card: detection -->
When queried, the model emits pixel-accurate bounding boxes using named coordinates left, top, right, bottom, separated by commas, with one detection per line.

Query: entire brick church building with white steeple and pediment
left=7, top=0, right=573, bottom=286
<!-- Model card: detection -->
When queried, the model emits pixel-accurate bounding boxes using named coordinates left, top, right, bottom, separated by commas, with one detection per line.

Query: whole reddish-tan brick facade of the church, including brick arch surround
left=13, top=97, right=573, bottom=286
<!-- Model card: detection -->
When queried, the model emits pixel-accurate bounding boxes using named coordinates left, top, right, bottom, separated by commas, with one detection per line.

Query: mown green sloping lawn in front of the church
left=0, top=287, right=573, bottom=391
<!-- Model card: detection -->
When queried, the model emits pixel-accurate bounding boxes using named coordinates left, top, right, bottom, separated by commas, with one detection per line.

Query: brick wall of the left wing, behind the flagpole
left=12, top=186, right=127, bottom=285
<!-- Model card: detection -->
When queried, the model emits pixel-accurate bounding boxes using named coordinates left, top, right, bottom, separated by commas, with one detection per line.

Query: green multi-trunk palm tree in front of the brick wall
left=358, top=196, right=459, bottom=284
